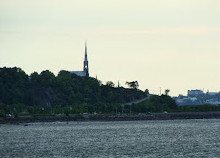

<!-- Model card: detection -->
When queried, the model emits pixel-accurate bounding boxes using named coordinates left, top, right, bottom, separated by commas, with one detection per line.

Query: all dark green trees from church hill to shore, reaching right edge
left=0, top=67, right=217, bottom=117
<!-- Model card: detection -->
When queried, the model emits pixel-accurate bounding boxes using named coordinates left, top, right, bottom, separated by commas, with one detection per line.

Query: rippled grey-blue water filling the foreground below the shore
left=0, top=119, right=220, bottom=158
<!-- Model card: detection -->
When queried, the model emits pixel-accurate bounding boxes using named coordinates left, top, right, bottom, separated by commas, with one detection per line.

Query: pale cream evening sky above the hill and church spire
left=0, top=0, right=220, bottom=96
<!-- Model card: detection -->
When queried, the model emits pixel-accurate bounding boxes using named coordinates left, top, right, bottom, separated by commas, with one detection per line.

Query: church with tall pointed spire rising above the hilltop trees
left=70, top=43, right=89, bottom=77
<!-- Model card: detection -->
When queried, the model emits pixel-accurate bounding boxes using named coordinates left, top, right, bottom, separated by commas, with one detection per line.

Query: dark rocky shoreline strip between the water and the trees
left=0, top=112, right=220, bottom=124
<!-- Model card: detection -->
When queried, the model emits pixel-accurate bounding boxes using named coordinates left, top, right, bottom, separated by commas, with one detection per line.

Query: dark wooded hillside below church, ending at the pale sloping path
left=0, top=67, right=146, bottom=116
